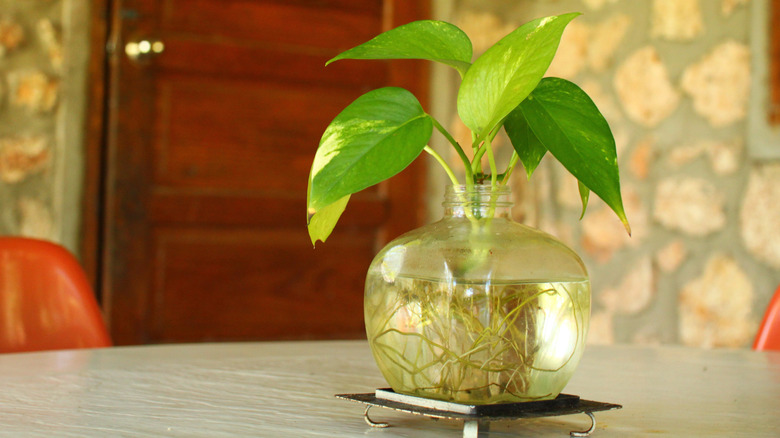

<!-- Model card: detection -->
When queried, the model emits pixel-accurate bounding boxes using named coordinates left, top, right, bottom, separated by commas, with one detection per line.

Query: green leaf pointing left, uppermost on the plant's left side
left=325, top=20, right=472, bottom=76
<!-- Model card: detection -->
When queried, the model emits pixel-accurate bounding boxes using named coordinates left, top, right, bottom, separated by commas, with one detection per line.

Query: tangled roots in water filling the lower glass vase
left=367, top=279, right=590, bottom=403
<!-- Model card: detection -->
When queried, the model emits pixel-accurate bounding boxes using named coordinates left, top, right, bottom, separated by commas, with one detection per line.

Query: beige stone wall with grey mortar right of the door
left=434, top=0, right=780, bottom=347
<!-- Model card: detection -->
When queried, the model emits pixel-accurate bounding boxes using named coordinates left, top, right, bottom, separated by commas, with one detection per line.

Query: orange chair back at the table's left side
left=0, top=237, right=111, bottom=353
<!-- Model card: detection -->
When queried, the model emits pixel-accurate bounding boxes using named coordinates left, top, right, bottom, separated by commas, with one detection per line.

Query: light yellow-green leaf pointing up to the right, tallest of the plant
left=458, top=12, right=580, bottom=140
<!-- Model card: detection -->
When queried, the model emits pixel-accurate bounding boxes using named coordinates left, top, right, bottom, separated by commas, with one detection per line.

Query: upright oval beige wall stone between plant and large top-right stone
left=614, top=46, right=680, bottom=127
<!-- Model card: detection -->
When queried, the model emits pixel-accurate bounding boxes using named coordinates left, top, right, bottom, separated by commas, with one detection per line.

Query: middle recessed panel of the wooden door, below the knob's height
left=155, top=78, right=362, bottom=192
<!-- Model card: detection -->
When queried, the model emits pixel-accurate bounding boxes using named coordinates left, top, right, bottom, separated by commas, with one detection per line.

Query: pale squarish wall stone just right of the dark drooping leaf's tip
left=653, top=177, right=726, bottom=236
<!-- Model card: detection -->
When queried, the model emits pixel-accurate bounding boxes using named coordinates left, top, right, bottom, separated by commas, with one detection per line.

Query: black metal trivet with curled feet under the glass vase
left=336, top=388, right=623, bottom=438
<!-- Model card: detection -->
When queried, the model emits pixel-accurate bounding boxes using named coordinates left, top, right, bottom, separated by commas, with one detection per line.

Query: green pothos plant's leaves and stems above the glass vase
left=307, top=13, right=630, bottom=244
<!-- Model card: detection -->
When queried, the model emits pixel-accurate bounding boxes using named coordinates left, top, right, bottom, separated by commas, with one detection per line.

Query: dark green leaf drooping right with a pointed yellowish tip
left=520, top=78, right=631, bottom=234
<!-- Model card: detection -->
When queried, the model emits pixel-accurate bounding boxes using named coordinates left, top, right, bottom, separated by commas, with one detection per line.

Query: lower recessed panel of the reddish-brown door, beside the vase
left=151, top=229, right=374, bottom=341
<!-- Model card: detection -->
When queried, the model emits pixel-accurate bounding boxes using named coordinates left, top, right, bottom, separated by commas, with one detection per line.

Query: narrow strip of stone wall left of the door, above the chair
left=0, top=0, right=89, bottom=250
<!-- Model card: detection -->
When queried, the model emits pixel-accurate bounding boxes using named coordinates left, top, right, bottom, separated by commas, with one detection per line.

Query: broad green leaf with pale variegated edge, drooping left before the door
left=307, top=87, right=433, bottom=218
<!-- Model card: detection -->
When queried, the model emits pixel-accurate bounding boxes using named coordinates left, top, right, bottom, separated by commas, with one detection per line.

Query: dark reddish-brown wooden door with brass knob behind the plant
left=101, top=0, right=427, bottom=344
